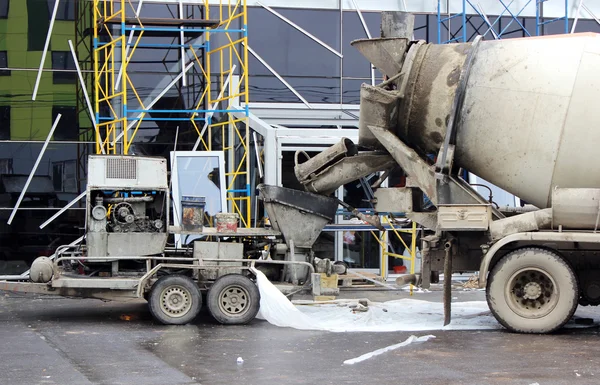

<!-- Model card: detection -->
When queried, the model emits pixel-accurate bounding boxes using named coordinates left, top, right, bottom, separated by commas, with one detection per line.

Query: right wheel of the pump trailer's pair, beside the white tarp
left=206, top=274, right=260, bottom=325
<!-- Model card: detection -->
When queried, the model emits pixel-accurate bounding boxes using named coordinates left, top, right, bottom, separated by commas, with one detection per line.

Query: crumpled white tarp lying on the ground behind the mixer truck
left=257, top=272, right=599, bottom=332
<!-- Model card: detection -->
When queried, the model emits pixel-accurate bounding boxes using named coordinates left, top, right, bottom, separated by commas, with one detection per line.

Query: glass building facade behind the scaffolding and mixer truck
left=0, top=0, right=600, bottom=273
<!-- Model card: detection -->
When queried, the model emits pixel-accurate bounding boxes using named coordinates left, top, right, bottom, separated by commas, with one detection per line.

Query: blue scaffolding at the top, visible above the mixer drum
left=437, top=0, right=569, bottom=44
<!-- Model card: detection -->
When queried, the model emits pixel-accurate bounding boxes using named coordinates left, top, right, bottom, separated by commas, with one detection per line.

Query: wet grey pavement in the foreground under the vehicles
left=0, top=291, right=600, bottom=385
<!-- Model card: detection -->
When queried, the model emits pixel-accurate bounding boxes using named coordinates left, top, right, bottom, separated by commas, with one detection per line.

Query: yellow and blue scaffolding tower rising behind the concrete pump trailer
left=93, top=0, right=251, bottom=227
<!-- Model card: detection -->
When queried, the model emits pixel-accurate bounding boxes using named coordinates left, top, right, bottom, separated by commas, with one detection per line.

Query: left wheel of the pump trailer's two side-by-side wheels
left=148, top=275, right=202, bottom=325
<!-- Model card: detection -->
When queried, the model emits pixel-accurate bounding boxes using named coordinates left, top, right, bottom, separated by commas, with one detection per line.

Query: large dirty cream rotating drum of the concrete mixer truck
left=353, top=33, right=600, bottom=208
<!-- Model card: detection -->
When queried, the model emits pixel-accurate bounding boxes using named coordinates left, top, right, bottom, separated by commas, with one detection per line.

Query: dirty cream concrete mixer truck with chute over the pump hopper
left=295, top=27, right=600, bottom=333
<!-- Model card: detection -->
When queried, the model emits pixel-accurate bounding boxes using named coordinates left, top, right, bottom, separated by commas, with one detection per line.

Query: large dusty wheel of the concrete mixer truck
left=486, top=247, right=578, bottom=333
